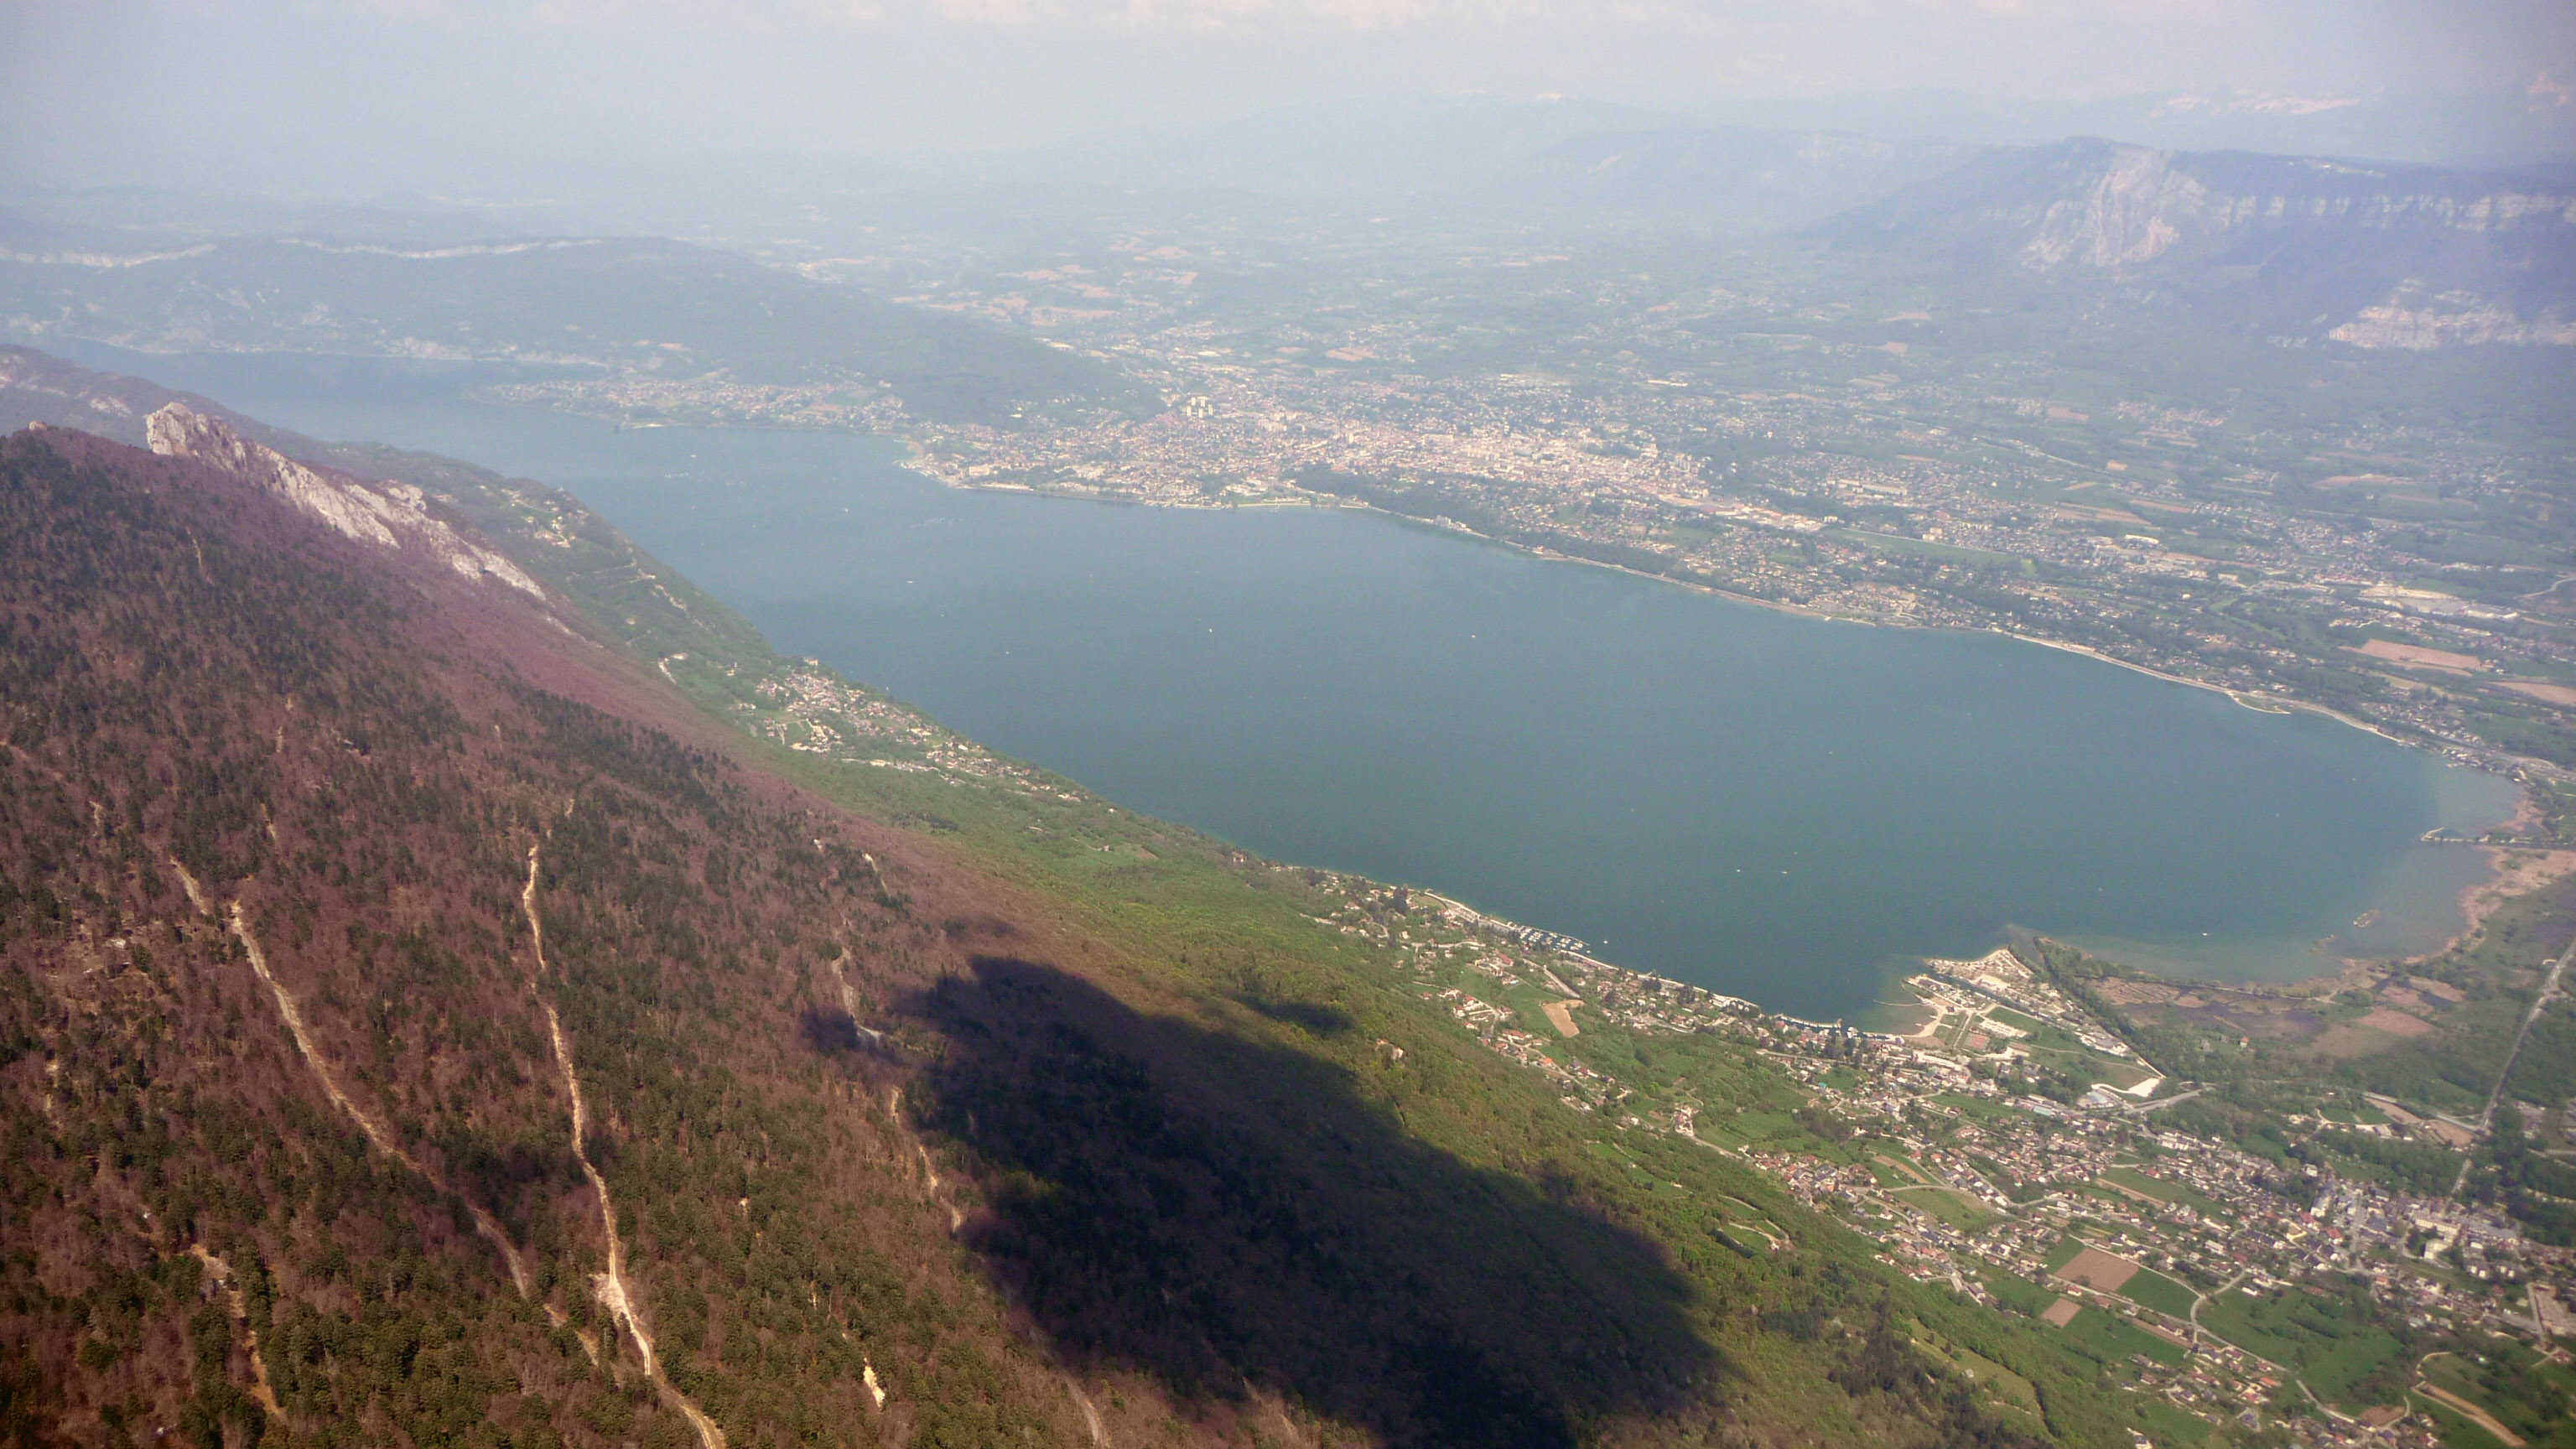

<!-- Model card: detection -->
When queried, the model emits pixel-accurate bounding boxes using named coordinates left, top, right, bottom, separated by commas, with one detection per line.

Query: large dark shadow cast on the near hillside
left=911, top=957, right=1723, bottom=1444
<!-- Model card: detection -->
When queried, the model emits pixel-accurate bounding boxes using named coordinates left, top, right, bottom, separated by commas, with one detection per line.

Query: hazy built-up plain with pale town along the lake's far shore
left=492, top=214, right=2576, bottom=819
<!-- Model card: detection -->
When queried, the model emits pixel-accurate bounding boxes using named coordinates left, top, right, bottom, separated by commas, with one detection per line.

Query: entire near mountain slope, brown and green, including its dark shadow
left=0, top=410, right=2125, bottom=1446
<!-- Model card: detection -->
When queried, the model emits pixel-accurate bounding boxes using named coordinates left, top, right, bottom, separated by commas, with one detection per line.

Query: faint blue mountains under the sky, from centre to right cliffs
left=1035, top=96, right=2576, bottom=351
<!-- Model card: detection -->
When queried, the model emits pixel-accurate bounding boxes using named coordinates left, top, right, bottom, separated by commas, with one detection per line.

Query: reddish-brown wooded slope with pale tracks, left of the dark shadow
left=0, top=420, right=1072, bottom=1444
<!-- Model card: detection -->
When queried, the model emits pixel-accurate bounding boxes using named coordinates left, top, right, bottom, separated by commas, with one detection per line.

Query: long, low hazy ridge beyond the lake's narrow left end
left=0, top=214, right=1123, bottom=420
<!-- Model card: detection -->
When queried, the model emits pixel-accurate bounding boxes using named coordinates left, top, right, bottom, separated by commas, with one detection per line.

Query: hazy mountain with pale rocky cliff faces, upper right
left=1816, top=139, right=2576, bottom=351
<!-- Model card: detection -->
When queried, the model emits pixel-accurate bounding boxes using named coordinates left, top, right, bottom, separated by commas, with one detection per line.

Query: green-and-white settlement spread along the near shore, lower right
left=1298, top=882, right=2576, bottom=1449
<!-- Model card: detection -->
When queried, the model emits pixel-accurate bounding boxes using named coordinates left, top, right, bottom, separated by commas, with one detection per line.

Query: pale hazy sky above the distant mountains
left=0, top=0, right=2576, bottom=194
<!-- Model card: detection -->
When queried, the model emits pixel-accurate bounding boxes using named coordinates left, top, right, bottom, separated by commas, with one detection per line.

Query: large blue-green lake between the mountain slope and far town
left=67, top=348, right=2514, bottom=1019
